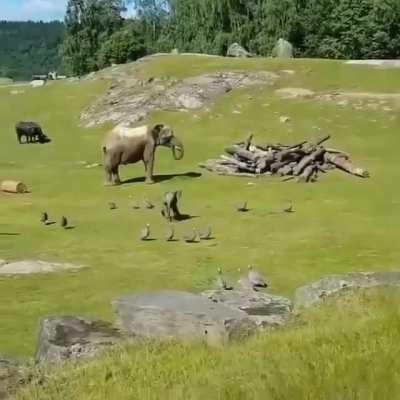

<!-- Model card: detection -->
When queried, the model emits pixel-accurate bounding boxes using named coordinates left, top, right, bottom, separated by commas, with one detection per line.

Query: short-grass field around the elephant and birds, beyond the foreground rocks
left=0, top=57, right=400, bottom=366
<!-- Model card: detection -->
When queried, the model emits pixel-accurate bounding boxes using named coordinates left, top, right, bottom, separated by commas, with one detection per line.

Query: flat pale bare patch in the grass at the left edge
left=0, top=260, right=84, bottom=275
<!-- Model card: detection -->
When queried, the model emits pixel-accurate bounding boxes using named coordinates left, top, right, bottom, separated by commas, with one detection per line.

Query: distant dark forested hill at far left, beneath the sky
left=0, top=21, right=64, bottom=80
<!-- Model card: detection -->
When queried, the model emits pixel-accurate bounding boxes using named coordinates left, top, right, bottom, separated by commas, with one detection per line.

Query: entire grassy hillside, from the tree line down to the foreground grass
left=0, top=55, right=400, bottom=400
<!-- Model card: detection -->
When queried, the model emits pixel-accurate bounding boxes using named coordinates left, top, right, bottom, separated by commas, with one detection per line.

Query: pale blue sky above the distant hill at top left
left=0, top=0, right=134, bottom=21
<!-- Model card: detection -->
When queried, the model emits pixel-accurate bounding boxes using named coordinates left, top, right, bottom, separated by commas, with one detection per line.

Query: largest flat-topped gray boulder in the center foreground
left=114, top=291, right=257, bottom=345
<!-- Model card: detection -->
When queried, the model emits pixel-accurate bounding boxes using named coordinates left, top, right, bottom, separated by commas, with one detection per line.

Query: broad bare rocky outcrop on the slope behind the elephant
left=81, top=61, right=279, bottom=127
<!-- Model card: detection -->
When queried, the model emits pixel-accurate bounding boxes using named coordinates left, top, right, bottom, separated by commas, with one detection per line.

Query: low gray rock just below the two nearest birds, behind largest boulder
left=203, top=289, right=292, bottom=328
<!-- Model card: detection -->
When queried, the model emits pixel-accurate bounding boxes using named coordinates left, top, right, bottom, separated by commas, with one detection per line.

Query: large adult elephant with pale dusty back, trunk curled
left=102, top=124, right=184, bottom=185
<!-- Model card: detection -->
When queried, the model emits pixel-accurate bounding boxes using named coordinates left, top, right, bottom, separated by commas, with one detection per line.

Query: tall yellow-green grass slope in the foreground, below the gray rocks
left=17, top=291, right=400, bottom=400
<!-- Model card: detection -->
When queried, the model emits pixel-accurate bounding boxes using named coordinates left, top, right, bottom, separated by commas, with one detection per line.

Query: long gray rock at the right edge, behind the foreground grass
left=294, top=271, right=400, bottom=310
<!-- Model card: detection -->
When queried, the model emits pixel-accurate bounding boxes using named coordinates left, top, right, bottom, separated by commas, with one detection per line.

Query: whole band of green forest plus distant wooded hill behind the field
left=0, top=0, right=400, bottom=78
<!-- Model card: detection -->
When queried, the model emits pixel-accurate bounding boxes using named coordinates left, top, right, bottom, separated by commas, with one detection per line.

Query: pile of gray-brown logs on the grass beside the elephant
left=200, top=135, right=369, bottom=182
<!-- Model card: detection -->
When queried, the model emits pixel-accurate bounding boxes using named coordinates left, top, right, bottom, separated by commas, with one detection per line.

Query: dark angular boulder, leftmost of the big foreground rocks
left=36, top=317, right=122, bottom=362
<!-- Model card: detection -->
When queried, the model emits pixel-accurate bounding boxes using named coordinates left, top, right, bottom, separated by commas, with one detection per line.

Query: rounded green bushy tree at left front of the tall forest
left=98, top=20, right=146, bottom=68
